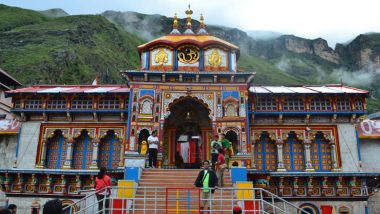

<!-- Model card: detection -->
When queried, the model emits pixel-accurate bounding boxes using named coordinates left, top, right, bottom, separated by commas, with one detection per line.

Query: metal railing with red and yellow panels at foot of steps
left=64, top=187, right=308, bottom=214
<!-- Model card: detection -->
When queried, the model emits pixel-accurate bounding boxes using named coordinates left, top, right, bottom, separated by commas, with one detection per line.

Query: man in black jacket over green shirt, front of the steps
left=194, top=160, right=218, bottom=212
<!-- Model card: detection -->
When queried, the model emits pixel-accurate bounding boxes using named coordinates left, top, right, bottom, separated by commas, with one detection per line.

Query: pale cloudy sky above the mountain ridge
left=0, top=0, right=380, bottom=48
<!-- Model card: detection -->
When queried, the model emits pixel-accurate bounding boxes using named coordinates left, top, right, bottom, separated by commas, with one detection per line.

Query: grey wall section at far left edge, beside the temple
left=0, top=134, right=17, bottom=169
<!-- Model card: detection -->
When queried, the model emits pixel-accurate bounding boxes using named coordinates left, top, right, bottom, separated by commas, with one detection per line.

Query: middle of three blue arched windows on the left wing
left=73, top=130, right=93, bottom=169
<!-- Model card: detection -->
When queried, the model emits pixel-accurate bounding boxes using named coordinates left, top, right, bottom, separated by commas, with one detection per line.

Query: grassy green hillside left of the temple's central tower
left=0, top=4, right=143, bottom=85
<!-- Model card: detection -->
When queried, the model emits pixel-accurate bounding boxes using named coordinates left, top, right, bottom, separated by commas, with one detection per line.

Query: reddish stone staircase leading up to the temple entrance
left=130, top=169, right=234, bottom=213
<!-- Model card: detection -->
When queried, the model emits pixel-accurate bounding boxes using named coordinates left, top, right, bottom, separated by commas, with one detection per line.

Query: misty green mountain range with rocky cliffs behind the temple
left=0, top=5, right=380, bottom=112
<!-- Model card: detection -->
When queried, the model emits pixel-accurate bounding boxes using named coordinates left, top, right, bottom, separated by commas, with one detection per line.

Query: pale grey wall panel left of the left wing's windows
left=17, top=122, right=41, bottom=169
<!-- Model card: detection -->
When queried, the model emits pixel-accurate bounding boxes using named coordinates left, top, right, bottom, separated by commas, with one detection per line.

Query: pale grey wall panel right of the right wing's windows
left=337, top=124, right=361, bottom=172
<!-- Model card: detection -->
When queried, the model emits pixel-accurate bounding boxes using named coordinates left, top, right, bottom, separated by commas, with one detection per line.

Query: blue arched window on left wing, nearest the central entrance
left=99, top=130, right=120, bottom=169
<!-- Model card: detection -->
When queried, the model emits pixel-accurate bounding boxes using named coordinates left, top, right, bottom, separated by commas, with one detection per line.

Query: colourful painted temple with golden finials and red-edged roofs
left=0, top=5, right=380, bottom=213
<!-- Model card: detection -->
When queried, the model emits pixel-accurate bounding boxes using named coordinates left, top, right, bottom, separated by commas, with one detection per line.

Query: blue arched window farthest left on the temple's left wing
left=46, top=130, right=66, bottom=169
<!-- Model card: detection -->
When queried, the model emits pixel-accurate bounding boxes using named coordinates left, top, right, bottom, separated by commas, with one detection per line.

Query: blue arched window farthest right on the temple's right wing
left=311, top=132, right=332, bottom=171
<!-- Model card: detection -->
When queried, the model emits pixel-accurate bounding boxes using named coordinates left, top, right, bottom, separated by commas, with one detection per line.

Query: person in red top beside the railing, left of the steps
left=95, top=167, right=111, bottom=214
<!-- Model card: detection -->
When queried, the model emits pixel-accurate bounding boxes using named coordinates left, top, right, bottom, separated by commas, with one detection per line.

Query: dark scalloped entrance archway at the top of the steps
left=163, top=96, right=212, bottom=168
